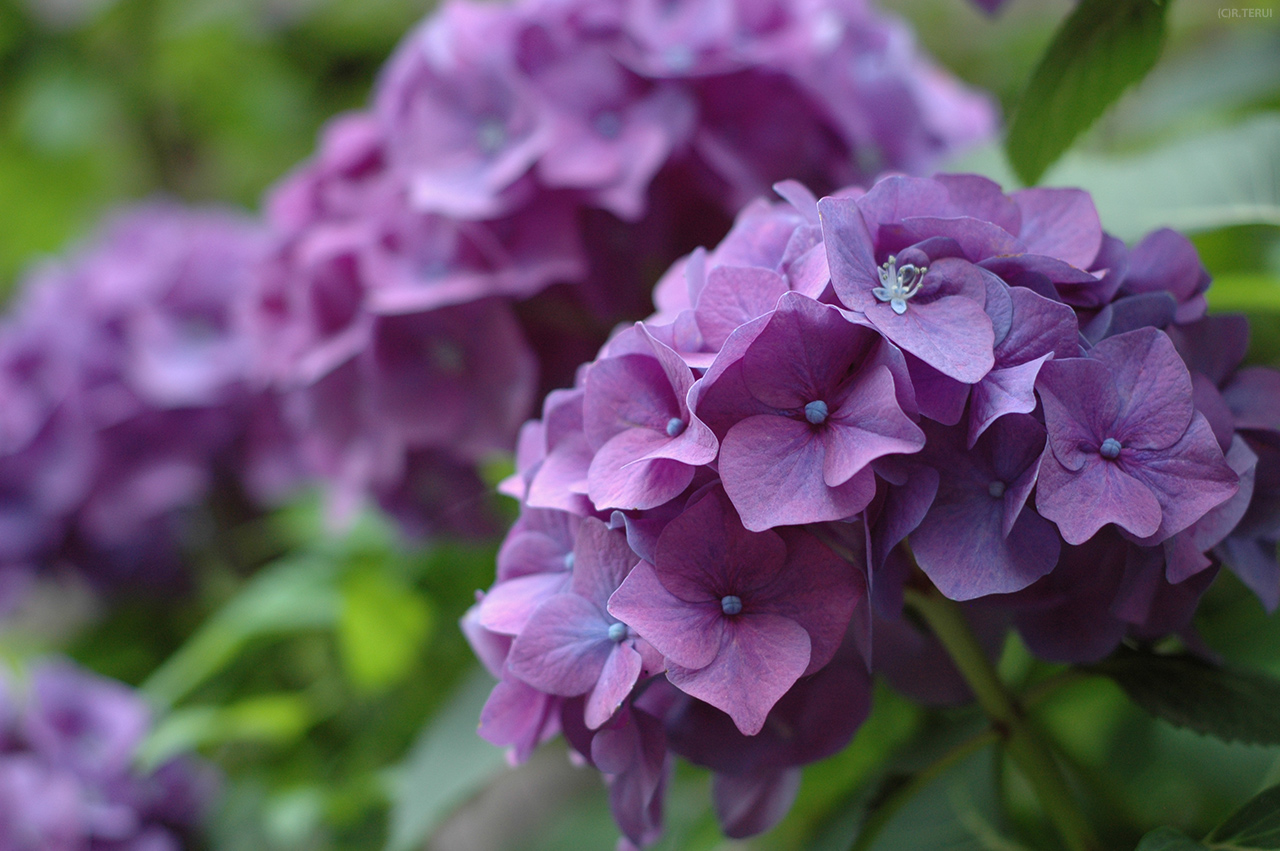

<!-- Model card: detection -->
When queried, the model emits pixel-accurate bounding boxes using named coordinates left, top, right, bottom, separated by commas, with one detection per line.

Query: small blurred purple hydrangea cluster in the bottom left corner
left=0, top=662, right=216, bottom=851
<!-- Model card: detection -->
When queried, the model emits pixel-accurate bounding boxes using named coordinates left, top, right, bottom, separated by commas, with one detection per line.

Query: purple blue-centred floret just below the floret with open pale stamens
left=701, top=293, right=924, bottom=531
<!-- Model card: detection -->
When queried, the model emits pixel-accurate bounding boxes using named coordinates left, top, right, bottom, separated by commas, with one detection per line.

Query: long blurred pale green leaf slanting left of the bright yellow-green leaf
left=142, top=557, right=340, bottom=706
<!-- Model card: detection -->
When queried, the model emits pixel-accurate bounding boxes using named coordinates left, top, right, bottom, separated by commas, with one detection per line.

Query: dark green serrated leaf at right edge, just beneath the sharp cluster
left=1092, top=649, right=1280, bottom=745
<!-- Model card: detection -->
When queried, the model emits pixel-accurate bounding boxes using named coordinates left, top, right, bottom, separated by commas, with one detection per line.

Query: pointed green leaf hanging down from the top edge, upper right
left=1006, top=0, right=1169, bottom=184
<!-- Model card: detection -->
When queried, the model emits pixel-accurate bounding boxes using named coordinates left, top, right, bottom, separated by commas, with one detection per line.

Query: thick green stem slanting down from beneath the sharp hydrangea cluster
left=906, top=587, right=1100, bottom=851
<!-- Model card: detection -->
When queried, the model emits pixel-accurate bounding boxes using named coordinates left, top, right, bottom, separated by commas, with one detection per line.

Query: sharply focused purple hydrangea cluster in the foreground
left=465, top=175, right=1280, bottom=845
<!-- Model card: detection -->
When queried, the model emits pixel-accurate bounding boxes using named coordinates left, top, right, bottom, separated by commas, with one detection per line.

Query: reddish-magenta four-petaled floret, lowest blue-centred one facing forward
left=608, top=491, right=861, bottom=736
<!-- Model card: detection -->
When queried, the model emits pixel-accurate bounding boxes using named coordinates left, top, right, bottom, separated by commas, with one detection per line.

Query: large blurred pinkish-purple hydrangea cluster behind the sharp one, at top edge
left=257, top=0, right=995, bottom=529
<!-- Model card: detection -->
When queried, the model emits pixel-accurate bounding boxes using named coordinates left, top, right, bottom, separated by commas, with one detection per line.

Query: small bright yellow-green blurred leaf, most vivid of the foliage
left=338, top=562, right=434, bottom=692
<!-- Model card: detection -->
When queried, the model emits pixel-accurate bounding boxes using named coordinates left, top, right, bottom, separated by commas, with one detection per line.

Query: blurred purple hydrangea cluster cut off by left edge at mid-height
left=0, top=203, right=271, bottom=589
